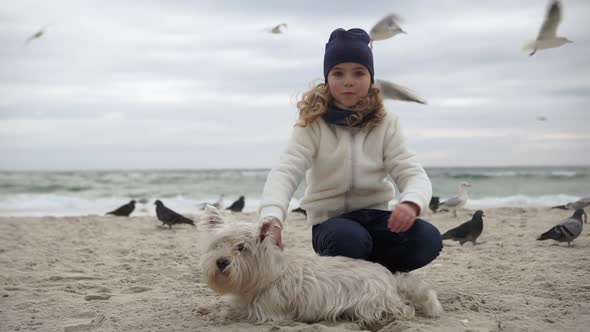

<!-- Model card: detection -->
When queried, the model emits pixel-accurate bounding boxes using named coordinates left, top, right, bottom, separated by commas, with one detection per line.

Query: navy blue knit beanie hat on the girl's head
left=324, top=28, right=375, bottom=83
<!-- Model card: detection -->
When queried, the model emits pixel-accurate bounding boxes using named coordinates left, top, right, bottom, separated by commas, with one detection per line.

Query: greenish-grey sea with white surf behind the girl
left=0, top=166, right=590, bottom=216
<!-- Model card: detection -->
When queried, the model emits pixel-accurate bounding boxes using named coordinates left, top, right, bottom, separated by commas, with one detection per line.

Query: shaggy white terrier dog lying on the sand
left=201, top=209, right=443, bottom=327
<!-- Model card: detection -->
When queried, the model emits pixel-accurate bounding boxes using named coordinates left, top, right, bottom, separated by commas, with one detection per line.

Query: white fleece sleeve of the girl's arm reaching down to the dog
left=258, top=124, right=317, bottom=222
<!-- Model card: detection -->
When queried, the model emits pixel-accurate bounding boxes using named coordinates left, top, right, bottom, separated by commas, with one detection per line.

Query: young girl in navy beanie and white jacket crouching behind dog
left=258, top=29, right=442, bottom=272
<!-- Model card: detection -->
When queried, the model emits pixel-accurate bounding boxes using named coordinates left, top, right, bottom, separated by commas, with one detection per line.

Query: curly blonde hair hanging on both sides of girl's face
left=295, top=82, right=385, bottom=130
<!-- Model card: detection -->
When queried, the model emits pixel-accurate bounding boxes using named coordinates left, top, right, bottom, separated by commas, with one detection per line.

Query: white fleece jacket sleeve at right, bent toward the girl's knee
left=383, top=113, right=432, bottom=215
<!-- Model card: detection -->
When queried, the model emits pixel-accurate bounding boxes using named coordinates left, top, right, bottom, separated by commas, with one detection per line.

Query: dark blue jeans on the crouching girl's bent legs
left=312, top=209, right=443, bottom=272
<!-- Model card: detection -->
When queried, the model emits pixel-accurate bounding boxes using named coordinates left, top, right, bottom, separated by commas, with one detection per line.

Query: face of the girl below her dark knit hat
left=328, top=62, right=371, bottom=107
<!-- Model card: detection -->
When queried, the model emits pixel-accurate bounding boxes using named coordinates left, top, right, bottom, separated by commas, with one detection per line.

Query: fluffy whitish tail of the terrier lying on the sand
left=398, top=273, right=443, bottom=317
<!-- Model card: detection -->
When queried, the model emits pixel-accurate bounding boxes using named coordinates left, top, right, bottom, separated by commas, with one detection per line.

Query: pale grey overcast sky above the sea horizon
left=0, top=0, right=590, bottom=170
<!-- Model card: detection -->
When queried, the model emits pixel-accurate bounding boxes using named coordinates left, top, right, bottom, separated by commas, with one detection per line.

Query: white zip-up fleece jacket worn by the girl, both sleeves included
left=258, top=113, right=432, bottom=225
